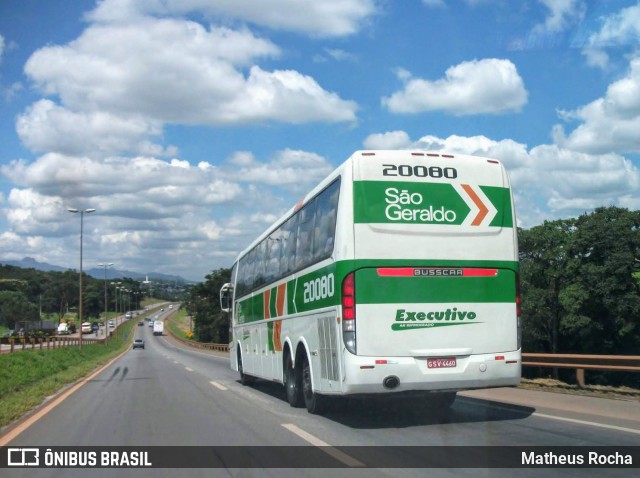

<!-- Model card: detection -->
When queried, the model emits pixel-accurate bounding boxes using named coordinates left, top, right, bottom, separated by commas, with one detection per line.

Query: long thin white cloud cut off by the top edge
left=88, top=0, right=377, bottom=37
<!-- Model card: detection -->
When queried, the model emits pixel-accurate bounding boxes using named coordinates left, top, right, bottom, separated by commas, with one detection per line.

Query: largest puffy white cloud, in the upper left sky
left=18, top=17, right=356, bottom=155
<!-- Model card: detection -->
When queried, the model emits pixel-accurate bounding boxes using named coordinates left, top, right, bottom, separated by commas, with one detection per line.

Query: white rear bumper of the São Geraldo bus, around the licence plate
left=342, top=351, right=522, bottom=394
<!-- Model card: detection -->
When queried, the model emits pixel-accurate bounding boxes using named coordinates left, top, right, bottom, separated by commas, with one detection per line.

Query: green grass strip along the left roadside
left=0, top=321, right=135, bottom=427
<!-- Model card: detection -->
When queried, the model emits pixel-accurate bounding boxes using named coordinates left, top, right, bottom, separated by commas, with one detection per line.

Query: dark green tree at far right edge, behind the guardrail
left=565, top=207, right=640, bottom=355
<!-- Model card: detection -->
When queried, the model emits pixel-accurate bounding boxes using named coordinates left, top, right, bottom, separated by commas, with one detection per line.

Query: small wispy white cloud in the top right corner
left=583, top=4, right=640, bottom=68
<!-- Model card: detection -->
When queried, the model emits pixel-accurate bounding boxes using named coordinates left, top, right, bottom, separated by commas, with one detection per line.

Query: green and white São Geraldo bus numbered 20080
left=220, top=151, right=521, bottom=413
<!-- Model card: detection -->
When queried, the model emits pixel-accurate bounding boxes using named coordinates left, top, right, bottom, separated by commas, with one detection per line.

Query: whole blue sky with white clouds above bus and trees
left=0, top=0, right=640, bottom=280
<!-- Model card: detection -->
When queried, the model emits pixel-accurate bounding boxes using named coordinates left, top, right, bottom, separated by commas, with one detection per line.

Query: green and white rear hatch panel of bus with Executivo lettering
left=355, top=266, right=517, bottom=356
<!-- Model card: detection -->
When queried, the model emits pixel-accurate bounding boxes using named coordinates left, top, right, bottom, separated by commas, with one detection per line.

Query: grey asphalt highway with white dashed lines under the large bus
left=2, top=323, right=640, bottom=478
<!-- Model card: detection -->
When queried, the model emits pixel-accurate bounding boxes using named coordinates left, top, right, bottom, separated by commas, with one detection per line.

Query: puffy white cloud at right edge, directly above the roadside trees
left=553, top=57, right=640, bottom=153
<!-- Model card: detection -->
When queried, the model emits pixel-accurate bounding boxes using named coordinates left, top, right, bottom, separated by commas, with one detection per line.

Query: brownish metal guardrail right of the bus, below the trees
left=522, top=353, right=640, bottom=387
